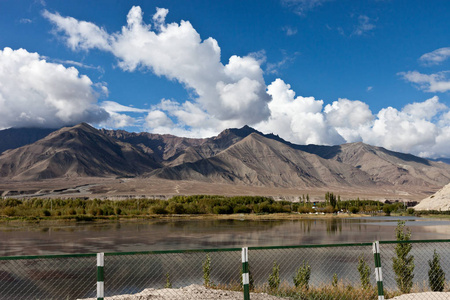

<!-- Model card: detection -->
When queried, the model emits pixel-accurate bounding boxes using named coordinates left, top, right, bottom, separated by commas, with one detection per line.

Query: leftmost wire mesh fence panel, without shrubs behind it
left=0, top=256, right=96, bottom=300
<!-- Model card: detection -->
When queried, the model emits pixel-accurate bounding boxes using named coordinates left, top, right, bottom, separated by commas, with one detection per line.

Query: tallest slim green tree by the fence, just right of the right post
left=392, top=221, right=415, bottom=294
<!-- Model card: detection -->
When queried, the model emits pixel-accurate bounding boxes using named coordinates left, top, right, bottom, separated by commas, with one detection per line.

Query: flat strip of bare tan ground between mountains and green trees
left=0, top=177, right=438, bottom=201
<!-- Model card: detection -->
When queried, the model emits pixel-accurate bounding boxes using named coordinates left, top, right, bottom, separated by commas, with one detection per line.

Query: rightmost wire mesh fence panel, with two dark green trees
left=380, top=241, right=450, bottom=299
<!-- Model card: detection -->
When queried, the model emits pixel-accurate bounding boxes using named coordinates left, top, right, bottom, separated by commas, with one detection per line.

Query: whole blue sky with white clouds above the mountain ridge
left=0, top=0, right=450, bottom=157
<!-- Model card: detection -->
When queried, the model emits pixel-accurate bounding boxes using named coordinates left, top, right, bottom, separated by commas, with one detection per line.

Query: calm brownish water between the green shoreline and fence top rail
left=0, top=217, right=450, bottom=256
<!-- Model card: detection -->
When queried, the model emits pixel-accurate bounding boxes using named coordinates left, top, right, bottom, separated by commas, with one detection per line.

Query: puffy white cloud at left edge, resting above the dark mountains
left=0, top=48, right=109, bottom=128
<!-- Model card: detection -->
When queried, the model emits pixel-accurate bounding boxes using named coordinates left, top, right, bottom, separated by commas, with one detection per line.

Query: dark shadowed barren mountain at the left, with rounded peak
left=0, top=123, right=159, bottom=180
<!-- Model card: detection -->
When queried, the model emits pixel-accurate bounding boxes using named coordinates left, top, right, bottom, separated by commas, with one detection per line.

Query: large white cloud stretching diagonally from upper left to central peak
left=44, top=6, right=270, bottom=132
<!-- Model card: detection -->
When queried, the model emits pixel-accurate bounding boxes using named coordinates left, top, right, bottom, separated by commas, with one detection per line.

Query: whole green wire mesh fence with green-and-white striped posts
left=0, top=240, right=450, bottom=300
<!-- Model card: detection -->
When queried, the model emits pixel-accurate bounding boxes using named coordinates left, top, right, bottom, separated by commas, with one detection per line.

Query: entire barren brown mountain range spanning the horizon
left=0, top=123, right=450, bottom=188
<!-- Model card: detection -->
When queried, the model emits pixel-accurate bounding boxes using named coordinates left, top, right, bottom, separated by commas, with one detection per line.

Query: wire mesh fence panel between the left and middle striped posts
left=100, top=250, right=242, bottom=299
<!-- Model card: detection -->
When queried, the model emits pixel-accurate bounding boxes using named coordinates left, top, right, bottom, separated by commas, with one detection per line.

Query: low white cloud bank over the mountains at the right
left=256, top=79, right=450, bottom=157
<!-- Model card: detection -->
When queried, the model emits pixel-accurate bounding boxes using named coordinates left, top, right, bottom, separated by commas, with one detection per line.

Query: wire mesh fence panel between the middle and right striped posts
left=249, top=244, right=377, bottom=299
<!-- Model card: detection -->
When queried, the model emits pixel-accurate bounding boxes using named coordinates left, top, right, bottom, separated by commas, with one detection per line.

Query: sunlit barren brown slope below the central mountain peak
left=152, top=133, right=374, bottom=187
